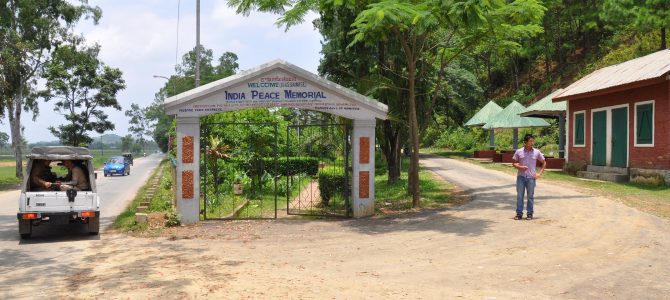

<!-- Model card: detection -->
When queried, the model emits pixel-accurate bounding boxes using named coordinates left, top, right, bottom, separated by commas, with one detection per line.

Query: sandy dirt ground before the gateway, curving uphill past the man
left=60, top=158, right=670, bottom=299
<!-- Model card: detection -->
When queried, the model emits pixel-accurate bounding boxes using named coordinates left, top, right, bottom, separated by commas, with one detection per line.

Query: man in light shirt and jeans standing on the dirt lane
left=512, top=133, right=546, bottom=220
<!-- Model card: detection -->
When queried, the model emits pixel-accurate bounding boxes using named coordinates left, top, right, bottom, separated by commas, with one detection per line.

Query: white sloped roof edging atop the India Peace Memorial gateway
left=165, top=59, right=388, bottom=120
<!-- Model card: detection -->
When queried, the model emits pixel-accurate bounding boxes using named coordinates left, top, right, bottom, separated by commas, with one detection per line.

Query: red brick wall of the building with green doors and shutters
left=567, top=80, right=670, bottom=170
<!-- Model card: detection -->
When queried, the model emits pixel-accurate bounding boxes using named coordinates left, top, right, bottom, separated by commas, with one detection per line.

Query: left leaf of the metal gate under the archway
left=200, top=123, right=278, bottom=220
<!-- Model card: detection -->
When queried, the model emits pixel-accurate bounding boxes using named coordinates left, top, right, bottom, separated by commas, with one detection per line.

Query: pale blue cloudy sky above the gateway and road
left=0, top=0, right=321, bottom=143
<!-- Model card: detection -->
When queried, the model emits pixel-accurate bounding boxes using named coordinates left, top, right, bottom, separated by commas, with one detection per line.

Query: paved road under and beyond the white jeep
left=0, top=155, right=162, bottom=299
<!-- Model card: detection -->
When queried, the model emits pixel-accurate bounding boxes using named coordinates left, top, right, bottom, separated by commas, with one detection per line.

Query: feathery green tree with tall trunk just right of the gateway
left=351, top=0, right=544, bottom=207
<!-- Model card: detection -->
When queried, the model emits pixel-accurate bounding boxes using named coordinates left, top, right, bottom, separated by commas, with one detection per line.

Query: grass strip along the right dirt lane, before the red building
left=422, top=149, right=670, bottom=219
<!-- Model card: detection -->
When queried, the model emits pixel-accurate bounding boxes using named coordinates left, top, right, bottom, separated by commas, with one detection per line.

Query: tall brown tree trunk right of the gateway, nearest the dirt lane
left=407, top=59, right=421, bottom=207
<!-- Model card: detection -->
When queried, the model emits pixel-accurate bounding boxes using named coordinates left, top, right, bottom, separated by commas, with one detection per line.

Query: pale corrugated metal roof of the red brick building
left=554, top=49, right=670, bottom=101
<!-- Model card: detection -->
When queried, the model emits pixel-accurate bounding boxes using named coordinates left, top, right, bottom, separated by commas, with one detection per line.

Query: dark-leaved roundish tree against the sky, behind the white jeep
left=41, top=42, right=126, bottom=146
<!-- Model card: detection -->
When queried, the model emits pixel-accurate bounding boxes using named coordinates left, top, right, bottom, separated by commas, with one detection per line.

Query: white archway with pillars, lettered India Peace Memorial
left=165, top=60, right=388, bottom=223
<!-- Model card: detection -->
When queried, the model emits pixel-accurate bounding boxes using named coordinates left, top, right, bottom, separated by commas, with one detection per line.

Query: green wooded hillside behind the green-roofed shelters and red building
left=422, top=1, right=670, bottom=150
